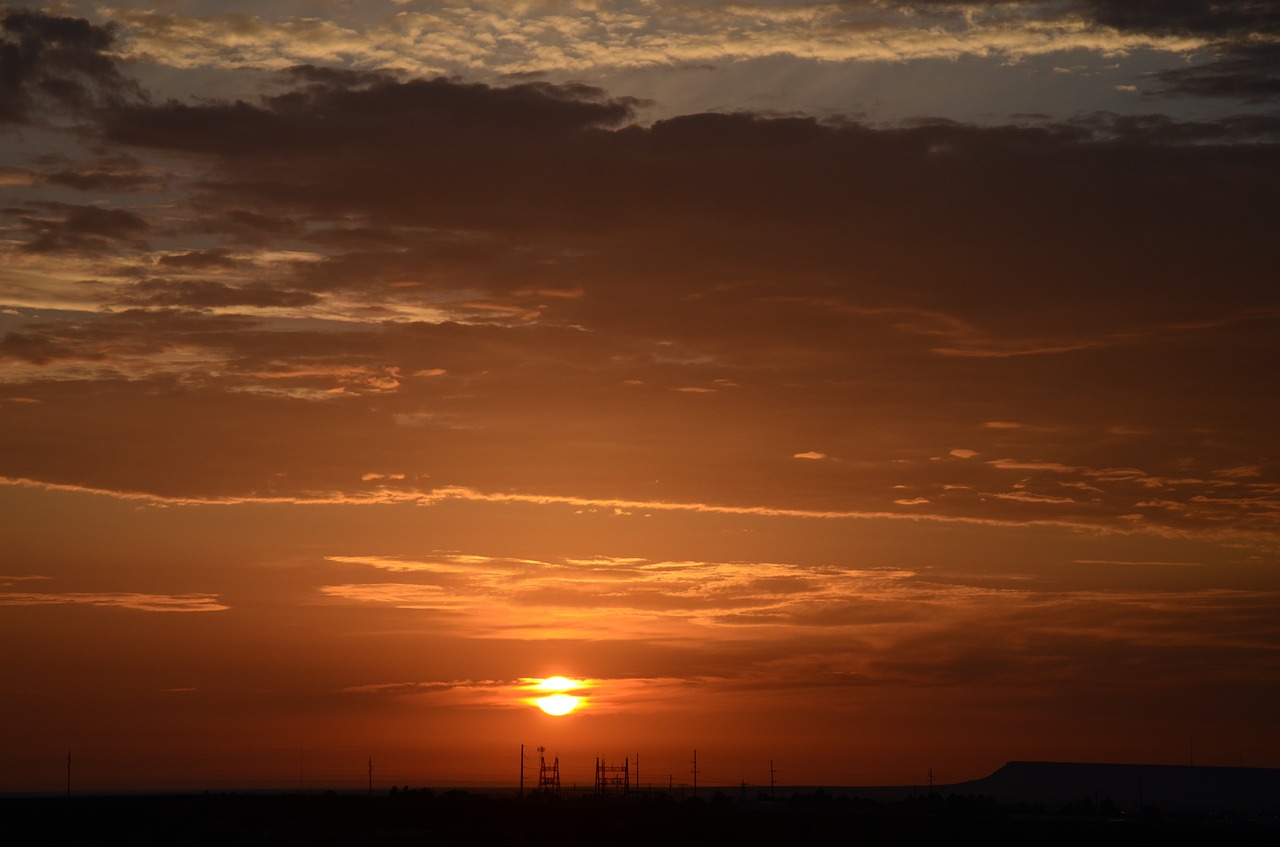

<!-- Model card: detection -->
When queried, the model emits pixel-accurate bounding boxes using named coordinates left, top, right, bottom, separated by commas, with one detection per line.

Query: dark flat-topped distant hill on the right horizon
left=936, top=761, right=1280, bottom=814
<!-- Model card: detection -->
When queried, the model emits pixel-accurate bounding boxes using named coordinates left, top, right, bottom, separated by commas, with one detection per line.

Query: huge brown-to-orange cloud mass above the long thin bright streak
left=0, top=70, right=1280, bottom=534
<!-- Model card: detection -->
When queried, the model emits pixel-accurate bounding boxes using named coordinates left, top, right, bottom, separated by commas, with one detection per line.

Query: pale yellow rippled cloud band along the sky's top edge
left=99, top=0, right=1202, bottom=82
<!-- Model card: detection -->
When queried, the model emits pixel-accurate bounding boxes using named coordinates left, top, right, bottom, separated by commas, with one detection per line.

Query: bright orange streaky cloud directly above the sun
left=321, top=554, right=936, bottom=638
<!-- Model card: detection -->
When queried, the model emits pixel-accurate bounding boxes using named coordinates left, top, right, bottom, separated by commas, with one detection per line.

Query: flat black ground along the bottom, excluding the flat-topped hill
left=0, top=789, right=1280, bottom=847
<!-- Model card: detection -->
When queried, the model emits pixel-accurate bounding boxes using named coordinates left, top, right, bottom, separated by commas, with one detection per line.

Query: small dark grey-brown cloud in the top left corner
left=0, top=9, right=141, bottom=124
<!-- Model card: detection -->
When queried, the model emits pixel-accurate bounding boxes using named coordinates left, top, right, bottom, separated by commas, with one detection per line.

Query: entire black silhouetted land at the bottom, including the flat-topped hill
left=0, top=763, right=1280, bottom=846
